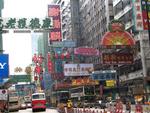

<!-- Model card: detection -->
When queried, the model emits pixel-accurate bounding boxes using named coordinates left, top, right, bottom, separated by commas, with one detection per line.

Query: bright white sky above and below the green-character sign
left=2, top=0, right=51, bottom=75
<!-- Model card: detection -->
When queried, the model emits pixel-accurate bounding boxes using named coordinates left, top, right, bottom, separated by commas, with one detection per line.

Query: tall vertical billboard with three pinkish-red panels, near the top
left=48, top=5, right=62, bottom=42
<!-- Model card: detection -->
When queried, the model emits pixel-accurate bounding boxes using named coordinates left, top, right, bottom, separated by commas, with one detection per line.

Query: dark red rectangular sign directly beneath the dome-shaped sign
left=102, top=53, right=133, bottom=64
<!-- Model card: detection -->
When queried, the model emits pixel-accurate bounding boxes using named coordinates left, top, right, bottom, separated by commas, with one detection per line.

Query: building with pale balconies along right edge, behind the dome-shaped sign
left=113, top=0, right=150, bottom=100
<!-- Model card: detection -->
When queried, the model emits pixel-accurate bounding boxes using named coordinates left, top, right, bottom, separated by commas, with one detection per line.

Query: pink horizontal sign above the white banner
left=74, top=47, right=99, bottom=56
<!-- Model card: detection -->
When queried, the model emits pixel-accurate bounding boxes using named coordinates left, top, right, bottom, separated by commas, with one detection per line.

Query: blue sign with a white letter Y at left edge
left=0, top=54, right=9, bottom=82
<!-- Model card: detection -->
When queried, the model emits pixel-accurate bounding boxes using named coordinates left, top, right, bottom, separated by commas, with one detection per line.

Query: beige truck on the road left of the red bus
left=9, top=90, right=20, bottom=111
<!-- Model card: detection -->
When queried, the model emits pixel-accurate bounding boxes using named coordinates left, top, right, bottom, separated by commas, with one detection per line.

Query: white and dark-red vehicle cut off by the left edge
left=0, top=89, right=9, bottom=113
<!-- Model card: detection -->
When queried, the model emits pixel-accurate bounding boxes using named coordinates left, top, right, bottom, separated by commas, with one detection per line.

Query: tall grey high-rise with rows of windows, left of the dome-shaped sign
left=77, top=0, right=113, bottom=70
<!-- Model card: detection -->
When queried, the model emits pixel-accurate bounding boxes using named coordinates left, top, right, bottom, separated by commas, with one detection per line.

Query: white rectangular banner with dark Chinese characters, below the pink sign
left=64, top=64, right=93, bottom=76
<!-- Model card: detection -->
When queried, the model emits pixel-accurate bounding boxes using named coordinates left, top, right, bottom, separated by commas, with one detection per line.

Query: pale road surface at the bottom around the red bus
left=11, top=109, right=58, bottom=113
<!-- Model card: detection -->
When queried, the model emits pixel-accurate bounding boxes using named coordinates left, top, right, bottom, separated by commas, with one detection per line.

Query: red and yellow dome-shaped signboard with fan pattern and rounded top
left=100, top=20, right=135, bottom=49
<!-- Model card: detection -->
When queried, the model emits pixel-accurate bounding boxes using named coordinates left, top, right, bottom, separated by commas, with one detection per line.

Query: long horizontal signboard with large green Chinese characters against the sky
left=0, top=17, right=53, bottom=33
